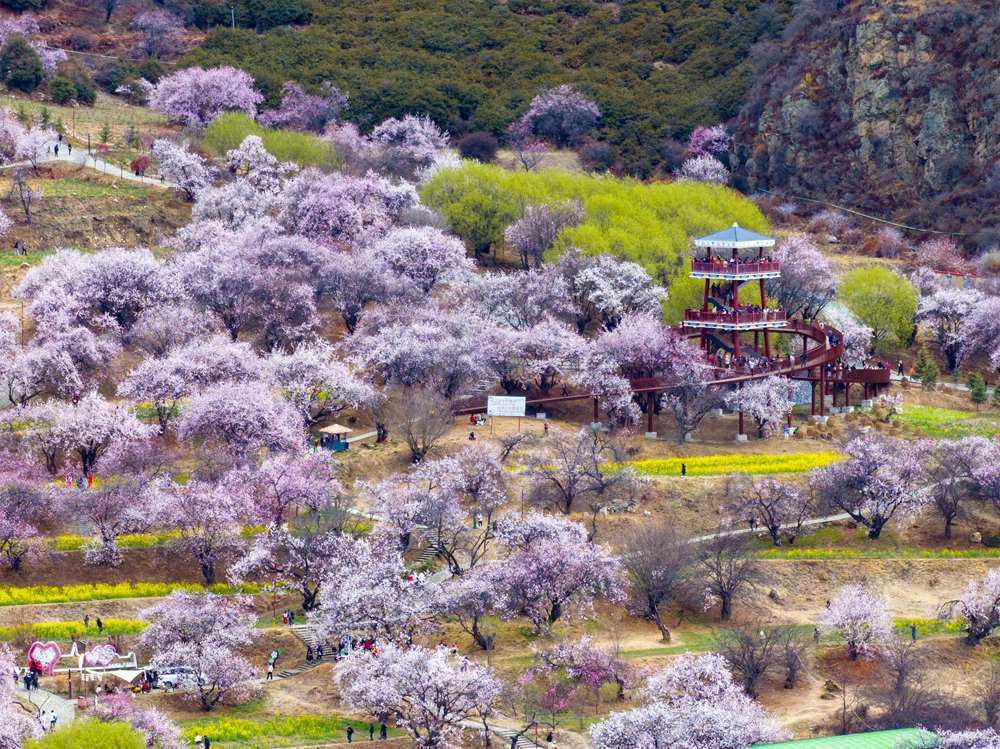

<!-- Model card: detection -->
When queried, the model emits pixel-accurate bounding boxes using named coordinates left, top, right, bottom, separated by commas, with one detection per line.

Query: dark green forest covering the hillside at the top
left=183, top=0, right=792, bottom=176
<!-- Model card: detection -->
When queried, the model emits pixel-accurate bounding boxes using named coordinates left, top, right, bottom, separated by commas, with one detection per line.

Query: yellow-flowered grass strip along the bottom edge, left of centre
left=181, top=715, right=402, bottom=749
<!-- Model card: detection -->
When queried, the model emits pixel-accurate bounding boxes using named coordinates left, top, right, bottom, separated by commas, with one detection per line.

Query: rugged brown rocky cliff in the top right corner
left=731, top=0, right=1000, bottom=250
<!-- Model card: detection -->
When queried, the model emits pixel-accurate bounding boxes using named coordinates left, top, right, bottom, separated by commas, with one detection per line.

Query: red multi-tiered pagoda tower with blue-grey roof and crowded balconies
left=683, top=223, right=788, bottom=358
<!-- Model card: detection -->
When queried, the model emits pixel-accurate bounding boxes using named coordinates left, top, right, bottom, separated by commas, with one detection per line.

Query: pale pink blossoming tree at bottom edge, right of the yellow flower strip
left=336, top=643, right=503, bottom=749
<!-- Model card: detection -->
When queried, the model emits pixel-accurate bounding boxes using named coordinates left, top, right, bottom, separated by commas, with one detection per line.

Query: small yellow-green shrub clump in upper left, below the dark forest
left=202, top=112, right=340, bottom=169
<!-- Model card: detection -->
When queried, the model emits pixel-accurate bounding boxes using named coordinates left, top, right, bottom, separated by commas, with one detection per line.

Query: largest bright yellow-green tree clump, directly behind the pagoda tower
left=421, top=162, right=769, bottom=322
